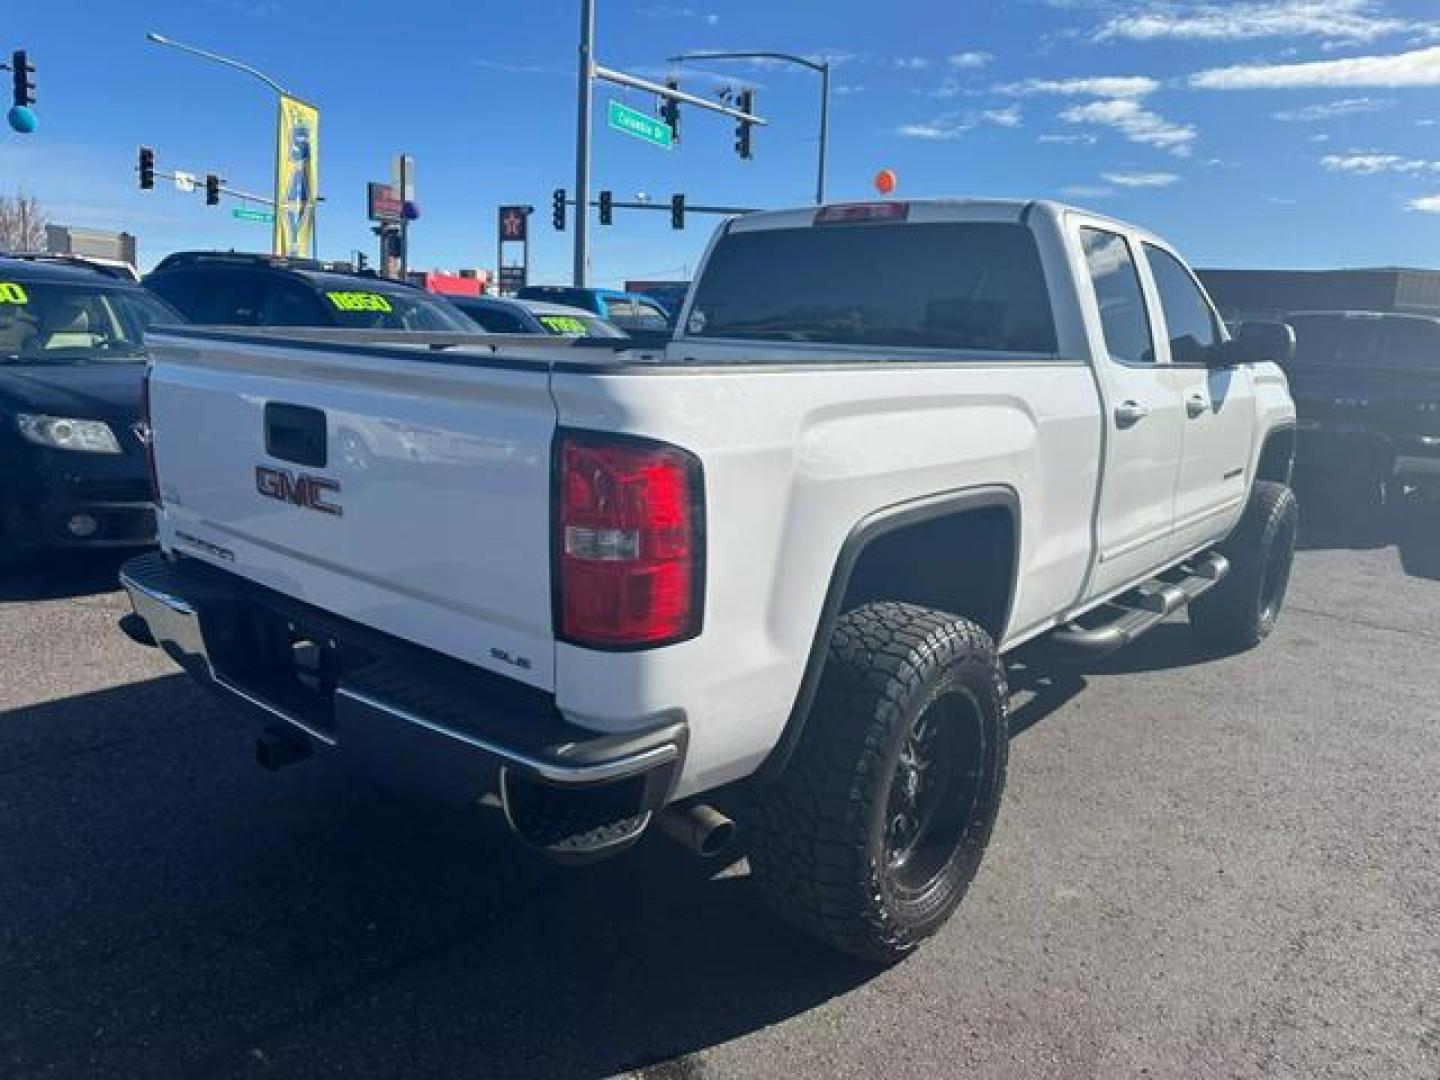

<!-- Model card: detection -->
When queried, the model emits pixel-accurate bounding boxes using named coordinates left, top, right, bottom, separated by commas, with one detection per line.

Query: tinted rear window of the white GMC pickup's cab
left=685, top=222, right=1056, bottom=353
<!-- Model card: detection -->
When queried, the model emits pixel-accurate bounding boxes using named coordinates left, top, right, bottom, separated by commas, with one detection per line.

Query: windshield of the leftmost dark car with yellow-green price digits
left=0, top=276, right=183, bottom=364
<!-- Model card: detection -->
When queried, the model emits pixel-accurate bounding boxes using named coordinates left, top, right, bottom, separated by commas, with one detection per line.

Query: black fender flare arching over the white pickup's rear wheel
left=755, top=484, right=1021, bottom=782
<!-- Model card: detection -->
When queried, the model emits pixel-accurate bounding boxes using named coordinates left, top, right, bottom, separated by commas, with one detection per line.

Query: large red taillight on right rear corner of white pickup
left=554, top=432, right=704, bottom=648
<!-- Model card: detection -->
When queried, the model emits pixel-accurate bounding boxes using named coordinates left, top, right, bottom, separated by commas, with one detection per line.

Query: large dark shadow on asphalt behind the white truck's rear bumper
left=0, top=675, right=877, bottom=1077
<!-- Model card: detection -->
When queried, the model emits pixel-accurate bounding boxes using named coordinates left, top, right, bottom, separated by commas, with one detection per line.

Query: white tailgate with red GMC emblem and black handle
left=147, top=331, right=556, bottom=690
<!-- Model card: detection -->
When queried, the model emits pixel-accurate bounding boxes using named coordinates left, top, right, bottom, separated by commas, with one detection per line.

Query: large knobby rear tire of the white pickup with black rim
left=747, top=602, right=1009, bottom=963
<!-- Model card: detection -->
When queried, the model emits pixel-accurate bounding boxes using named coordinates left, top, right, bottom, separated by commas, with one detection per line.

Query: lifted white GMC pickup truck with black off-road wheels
left=122, top=200, right=1296, bottom=962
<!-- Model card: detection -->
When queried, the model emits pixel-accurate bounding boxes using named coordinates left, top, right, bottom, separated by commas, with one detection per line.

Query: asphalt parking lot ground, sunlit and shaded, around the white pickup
left=0, top=495, right=1440, bottom=1079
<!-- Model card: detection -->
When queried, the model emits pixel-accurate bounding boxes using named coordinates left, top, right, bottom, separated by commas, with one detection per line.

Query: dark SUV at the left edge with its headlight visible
left=0, top=255, right=184, bottom=563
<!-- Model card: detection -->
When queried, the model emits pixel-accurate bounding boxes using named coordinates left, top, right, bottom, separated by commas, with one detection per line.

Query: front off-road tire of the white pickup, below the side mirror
left=1189, top=480, right=1300, bottom=652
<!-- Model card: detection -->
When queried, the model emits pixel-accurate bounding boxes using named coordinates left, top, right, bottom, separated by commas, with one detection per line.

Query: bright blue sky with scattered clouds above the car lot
left=0, top=0, right=1440, bottom=284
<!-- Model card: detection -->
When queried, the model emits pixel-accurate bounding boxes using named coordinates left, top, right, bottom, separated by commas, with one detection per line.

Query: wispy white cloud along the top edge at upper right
left=1094, top=0, right=1424, bottom=42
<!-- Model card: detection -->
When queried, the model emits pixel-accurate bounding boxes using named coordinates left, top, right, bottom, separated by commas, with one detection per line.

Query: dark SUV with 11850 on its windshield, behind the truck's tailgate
left=144, top=252, right=475, bottom=333
